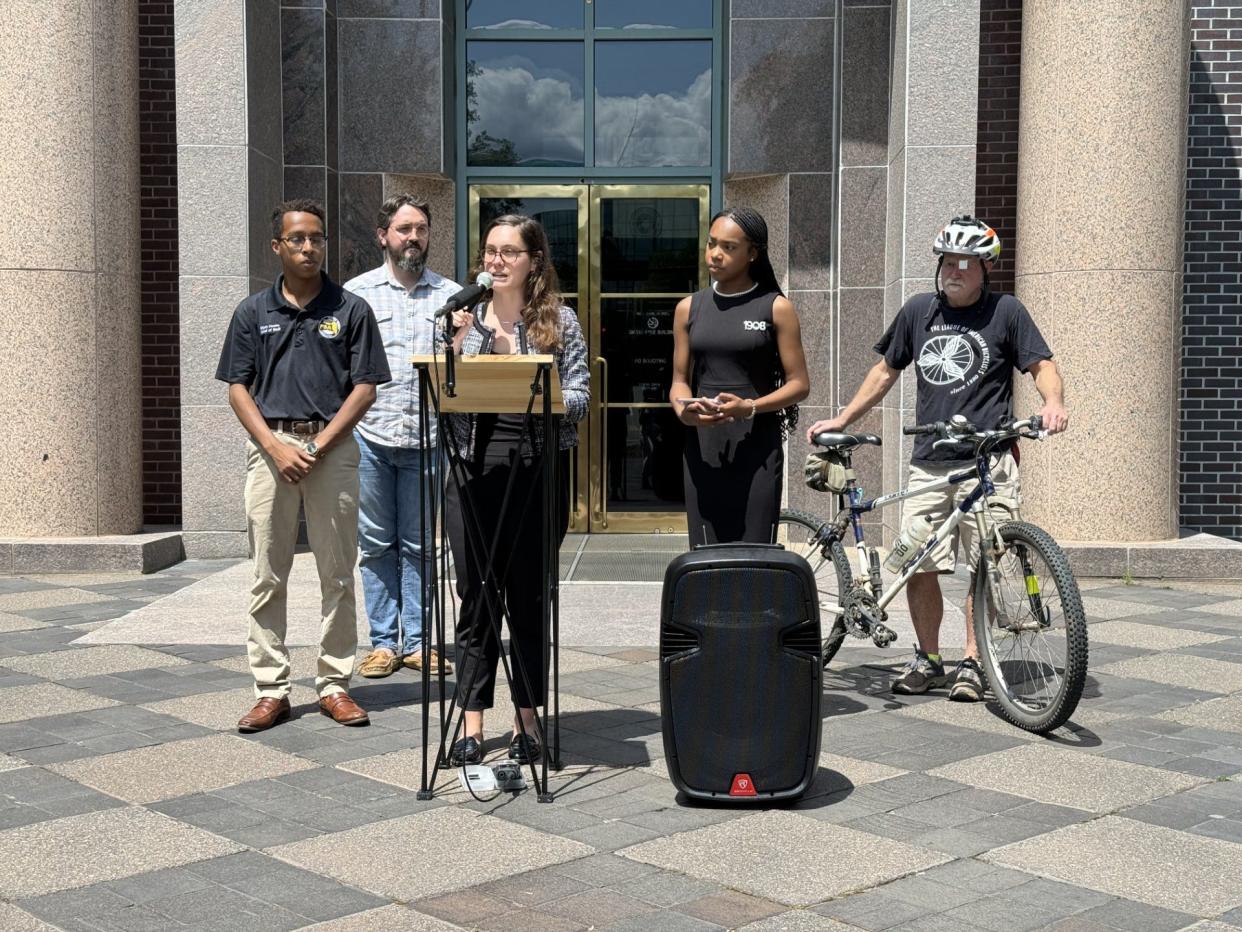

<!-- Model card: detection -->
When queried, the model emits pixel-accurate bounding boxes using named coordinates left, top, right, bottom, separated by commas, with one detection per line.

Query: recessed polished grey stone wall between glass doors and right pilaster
left=724, top=0, right=891, bottom=526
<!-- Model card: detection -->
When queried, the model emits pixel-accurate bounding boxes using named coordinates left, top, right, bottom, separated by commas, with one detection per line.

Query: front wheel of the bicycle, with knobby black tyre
left=974, top=521, right=1087, bottom=733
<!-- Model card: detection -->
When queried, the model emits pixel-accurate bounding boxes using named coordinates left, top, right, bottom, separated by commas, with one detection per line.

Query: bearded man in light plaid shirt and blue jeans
left=345, top=194, right=461, bottom=678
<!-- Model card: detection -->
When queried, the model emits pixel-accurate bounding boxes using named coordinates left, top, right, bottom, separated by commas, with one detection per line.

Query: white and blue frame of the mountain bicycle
left=820, top=455, right=996, bottom=616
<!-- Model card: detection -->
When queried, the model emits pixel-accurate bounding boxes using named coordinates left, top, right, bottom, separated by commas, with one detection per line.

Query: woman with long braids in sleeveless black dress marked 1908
left=668, top=208, right=811, bottom=547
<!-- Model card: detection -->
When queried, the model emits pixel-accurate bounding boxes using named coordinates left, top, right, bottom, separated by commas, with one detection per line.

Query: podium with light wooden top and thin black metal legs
left=410, top=354, right=565, bottom=803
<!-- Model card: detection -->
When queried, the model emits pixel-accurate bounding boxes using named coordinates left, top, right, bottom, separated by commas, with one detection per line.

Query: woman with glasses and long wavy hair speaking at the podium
left=446, top=214, right=590, bottom=767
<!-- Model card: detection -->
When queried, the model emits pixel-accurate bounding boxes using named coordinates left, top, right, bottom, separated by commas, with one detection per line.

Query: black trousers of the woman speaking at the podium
left=445, top=449, right=569, bottom=712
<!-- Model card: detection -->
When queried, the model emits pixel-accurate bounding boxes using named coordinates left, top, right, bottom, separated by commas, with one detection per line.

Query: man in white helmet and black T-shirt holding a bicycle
left=806, top=216, right=1069, bottom=702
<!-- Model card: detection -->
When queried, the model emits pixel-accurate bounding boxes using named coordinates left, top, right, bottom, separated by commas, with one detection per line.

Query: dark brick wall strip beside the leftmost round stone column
left=138, top=0, right=181, bottom=524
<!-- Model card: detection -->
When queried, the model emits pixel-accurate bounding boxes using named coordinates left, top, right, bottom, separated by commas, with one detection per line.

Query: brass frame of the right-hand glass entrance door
left=587, top=184, right=712, bottom=534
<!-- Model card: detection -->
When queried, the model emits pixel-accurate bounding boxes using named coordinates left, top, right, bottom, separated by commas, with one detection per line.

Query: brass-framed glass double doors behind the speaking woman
left=468, top=184, right=709, bottom=533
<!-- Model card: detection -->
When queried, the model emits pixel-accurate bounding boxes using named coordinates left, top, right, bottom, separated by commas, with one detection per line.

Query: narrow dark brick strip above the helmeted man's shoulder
left=975, top=0, right=1022, bottom=292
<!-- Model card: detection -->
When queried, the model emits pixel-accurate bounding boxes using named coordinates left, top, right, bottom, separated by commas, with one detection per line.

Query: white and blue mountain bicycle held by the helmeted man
left=777, top=415, right=1087, bottom=733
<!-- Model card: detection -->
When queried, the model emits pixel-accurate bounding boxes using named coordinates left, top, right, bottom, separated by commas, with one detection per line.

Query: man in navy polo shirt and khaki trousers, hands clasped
left=216, top=200, right=391, bottom=732
